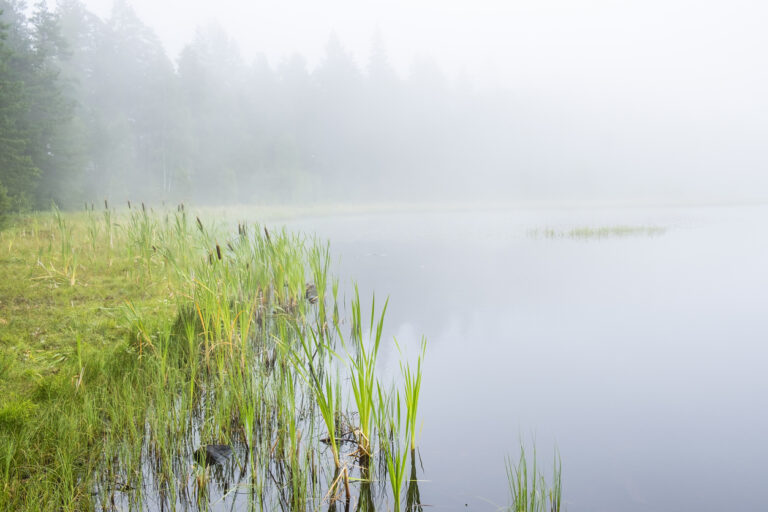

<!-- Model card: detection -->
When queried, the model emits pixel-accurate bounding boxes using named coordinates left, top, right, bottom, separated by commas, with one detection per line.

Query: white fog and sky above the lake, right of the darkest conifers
left=7, top=0, right=768, bottom=203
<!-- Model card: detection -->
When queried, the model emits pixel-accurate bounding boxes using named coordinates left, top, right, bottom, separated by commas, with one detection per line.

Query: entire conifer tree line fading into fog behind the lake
left=0, top=0, right=513, bottom=218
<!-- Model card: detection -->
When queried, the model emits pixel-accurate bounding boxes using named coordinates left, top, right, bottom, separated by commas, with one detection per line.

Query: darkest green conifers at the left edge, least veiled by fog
left=0, top=1, right=80, bottom=211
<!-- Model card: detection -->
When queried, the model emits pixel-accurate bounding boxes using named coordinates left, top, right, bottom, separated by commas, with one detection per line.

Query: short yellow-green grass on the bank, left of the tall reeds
left=0, top=208, right=173, bottom=510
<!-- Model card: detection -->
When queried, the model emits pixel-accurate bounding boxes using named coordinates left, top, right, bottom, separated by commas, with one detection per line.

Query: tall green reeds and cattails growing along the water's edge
left=6, top=202, right=432, bottom=509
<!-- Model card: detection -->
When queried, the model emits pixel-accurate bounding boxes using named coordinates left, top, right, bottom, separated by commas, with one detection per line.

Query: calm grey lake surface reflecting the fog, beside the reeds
left=280, top=207, right=768, bottom=512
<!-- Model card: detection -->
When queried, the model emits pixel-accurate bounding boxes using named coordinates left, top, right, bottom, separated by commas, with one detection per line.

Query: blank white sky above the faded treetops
left=69, top=0, right=768, bottom=95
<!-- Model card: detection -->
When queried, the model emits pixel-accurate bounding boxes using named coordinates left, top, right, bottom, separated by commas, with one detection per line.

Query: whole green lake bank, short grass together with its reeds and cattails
left=0, top=202, right=426, bottom=510
